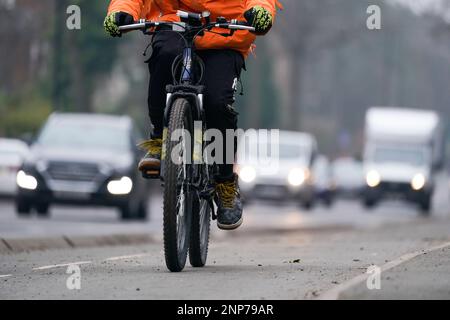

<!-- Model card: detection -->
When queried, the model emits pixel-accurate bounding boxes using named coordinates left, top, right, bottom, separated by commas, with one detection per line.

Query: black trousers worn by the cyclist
left=148, top=32, right=245, bottom=180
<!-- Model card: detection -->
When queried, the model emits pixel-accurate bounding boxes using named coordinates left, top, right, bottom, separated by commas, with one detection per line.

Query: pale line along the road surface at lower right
left=318, top=242, right=450, bottom=300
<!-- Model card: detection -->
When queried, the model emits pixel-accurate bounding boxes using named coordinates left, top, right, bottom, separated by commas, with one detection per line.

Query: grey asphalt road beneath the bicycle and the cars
left=0, top=174, right=450, bottom=299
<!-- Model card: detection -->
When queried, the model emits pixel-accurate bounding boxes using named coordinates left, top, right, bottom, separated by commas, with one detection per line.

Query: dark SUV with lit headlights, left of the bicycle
left=16, top=113, right=148, bottom=219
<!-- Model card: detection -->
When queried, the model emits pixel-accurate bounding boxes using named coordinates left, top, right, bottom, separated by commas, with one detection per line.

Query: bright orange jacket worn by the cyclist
left=108, top=0, right=281, bottom=56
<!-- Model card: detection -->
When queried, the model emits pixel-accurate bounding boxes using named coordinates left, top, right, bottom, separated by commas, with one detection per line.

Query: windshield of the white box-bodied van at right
left=374, top=148, right=426, bottom=166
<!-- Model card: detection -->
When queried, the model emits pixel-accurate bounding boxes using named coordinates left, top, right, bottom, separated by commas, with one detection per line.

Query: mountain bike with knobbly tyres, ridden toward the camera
left=119, top=11, right=255, bottom=272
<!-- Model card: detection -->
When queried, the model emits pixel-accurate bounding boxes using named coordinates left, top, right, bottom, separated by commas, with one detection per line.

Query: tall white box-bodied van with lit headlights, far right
left=363, top=107, right=444, bottom=214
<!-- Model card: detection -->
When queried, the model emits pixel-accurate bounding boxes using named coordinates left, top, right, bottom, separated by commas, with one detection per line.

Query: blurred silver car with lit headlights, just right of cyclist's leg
left=237, top=131, right=317, bottom=209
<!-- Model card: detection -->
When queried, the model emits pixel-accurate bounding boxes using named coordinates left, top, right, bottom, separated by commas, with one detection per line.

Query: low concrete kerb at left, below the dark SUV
left=0, top=234, right=156, bottom=254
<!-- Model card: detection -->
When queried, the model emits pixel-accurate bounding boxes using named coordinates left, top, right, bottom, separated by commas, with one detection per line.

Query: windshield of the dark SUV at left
left=38, top=121, right=130, bottom=151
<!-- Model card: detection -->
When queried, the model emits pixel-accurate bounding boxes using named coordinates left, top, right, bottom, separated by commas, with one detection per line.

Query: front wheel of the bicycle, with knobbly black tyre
left=163, top=99, right=193, bottom=272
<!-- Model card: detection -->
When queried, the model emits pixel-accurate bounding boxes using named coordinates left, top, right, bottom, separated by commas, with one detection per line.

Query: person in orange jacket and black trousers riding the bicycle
left=104, top=0, right=281, bottom=230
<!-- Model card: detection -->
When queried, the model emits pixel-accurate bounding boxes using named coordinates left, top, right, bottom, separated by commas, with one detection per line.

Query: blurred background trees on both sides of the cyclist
left=0, top=0, right=450, bottom=155
